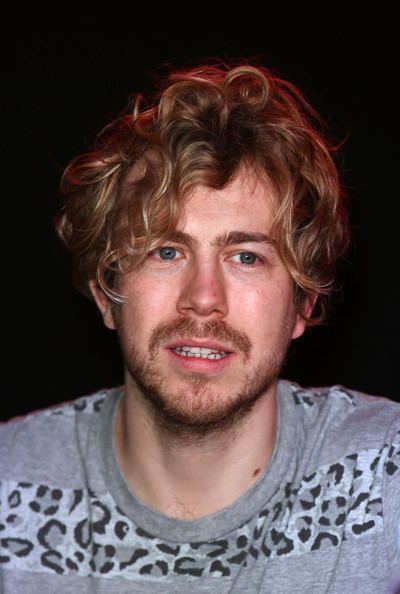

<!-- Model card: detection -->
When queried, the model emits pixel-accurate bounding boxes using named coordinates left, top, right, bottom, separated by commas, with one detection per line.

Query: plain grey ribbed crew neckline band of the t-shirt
left=98, top=380, right=296, bottom=543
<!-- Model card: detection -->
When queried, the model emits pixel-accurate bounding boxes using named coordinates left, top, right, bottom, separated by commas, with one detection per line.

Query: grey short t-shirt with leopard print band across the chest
left=0, top=380, right=400, bottom=594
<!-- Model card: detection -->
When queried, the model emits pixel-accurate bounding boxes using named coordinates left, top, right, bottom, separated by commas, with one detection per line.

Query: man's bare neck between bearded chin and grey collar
left=115, top=376, right=277, bottom=519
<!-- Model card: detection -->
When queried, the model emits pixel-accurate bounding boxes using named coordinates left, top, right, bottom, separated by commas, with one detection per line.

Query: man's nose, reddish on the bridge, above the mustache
left=177, top=261, right=228, bottom=318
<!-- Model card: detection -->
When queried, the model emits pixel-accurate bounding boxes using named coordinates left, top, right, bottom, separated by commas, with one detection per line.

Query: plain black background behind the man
left=1, top=2, right=399, bottom=418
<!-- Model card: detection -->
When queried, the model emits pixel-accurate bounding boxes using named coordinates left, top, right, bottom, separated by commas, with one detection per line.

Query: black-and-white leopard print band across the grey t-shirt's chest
left=0, top=439, right=400, bottom=579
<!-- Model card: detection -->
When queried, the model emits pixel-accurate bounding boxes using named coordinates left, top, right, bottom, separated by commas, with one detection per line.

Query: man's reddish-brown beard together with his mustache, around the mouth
left=120, top=319, right=290, bottom=439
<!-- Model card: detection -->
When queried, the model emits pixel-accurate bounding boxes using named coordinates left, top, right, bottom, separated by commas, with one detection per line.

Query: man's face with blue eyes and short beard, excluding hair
left=92, top=170, right=305, bottom=431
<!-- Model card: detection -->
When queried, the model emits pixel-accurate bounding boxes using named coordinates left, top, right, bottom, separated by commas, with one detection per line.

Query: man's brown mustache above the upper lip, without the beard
left=149, top=318, right=252, bottom=359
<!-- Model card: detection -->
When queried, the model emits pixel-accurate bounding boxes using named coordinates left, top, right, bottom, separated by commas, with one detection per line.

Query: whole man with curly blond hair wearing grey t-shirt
left=0, top=65, right=400, bottom=594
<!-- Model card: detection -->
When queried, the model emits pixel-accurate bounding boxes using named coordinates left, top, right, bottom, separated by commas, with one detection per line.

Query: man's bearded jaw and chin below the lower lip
left=123, top=354, right=277, bottom=445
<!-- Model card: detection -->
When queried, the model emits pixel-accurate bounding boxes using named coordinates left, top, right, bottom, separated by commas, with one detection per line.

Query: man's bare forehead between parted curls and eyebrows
left=177, top=168, right=276, bottom=233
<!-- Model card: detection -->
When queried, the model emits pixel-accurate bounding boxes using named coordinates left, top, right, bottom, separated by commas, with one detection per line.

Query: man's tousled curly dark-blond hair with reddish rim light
left=56, top=63, right=349, bottom=324
